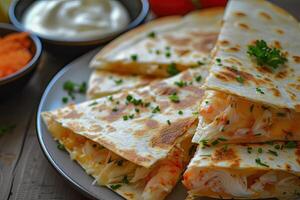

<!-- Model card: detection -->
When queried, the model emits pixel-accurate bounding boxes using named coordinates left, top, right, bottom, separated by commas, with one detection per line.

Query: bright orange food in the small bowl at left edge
left=0, top=33, right=33, bottom=78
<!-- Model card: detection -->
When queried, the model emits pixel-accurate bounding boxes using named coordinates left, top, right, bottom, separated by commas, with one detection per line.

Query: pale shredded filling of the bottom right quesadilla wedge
left=183, top=167, right=300, bottom=199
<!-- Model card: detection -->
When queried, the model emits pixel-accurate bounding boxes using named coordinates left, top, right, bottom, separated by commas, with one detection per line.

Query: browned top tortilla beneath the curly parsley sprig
left=206, top=0, right=300, bottom=112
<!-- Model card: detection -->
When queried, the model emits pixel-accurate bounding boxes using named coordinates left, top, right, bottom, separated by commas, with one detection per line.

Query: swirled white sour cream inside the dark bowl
left=23, top=0, right=130, bottom=40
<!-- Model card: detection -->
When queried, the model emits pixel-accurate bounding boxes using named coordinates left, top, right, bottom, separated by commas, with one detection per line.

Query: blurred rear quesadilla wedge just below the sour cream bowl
left=90, top=8, right=223, bottom=77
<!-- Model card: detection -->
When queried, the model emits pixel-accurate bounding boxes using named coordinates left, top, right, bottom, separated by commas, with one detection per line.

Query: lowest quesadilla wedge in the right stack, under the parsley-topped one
left=183, top=142, right=300, bottom=199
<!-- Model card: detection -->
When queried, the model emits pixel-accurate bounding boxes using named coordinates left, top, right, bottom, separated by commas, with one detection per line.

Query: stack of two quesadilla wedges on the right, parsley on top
left=183, top=0, right=300, bottom=199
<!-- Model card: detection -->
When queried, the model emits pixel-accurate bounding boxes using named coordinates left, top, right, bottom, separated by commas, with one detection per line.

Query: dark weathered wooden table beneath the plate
left=0, top=0, right=300, bottom=200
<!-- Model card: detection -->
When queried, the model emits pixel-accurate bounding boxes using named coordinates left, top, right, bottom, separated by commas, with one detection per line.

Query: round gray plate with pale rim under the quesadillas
left=37, top=49, right=190, bottom=200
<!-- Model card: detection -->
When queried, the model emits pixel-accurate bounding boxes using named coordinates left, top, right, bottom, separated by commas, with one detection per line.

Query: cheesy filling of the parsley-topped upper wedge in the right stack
left=193, top=91, right=300, bottom=143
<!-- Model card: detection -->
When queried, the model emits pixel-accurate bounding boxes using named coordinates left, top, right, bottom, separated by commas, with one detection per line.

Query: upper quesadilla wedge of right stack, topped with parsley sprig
left=193, top=0, right=300, bottom=144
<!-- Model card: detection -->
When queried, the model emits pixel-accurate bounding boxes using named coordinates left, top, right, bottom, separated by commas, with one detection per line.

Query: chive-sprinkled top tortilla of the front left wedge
left=43, top=68, right=208, bottom=167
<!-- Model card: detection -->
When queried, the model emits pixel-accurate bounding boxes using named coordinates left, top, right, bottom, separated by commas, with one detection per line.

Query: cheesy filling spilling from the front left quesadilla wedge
left=48, top=120, right=190, bottom=199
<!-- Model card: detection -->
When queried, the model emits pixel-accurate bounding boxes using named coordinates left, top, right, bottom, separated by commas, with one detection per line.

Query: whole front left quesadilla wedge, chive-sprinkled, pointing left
left=42, top=68, right=208, bottom=200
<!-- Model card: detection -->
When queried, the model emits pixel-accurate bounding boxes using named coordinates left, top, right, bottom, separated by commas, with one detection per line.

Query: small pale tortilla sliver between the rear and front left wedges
left=87, top=70, right=161, bottom=99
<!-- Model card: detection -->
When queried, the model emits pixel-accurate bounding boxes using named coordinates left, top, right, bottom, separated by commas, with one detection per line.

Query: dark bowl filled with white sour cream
left=9, top=0, right=149, bottom=58
